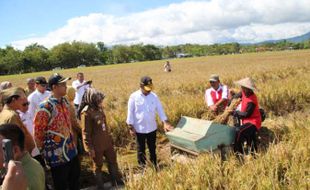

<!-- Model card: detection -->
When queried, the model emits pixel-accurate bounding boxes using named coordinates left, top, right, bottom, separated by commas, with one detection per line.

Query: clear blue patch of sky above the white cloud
left=0, top=0, right=181, bottom=47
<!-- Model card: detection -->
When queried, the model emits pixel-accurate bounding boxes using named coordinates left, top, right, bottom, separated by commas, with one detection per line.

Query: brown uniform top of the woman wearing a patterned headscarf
left=81, top=106, right=113, bottom=152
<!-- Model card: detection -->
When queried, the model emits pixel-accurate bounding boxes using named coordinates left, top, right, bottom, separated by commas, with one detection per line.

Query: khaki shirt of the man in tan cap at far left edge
left=0, top=105, right=34, bottom=153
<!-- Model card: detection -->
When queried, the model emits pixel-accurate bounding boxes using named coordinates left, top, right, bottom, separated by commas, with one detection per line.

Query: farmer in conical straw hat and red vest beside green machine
left=233, top=78, right=262, bottom=154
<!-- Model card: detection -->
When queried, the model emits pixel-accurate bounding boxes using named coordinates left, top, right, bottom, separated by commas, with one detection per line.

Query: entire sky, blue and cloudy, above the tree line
left=0, top=0, right=310, bottom=49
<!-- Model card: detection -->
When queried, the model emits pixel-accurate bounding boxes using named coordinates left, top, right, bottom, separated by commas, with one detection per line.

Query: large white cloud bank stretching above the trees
left=12, top=0, right=310, bottom=49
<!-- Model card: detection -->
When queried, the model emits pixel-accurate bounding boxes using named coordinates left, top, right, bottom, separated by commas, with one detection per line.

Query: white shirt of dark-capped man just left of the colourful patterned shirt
left=27, top=90, right=51, bottom=121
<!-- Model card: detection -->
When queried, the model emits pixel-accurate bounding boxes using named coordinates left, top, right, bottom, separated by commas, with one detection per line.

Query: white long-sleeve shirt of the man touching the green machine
left=126, top=90, right=167, bottom=133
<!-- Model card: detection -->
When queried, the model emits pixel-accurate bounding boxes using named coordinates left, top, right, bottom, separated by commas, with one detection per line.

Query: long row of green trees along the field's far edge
left=0, top=40, right=310, bottom=75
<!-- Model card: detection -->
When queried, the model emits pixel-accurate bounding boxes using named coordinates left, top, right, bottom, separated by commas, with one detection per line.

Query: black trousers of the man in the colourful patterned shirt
left=51, top=156, right=81, bottom=190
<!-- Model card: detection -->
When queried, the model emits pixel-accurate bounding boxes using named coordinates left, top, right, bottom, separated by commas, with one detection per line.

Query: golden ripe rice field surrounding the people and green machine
left=0, top=50, right=310, bottom=189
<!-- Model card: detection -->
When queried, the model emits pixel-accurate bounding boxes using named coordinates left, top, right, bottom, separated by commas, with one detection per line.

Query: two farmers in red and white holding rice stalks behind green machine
left=205, top=74, right=262, bottom=155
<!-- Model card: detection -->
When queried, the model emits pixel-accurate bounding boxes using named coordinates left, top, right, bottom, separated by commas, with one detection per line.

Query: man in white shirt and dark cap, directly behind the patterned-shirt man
left=27, top=77, right=51, bottom=121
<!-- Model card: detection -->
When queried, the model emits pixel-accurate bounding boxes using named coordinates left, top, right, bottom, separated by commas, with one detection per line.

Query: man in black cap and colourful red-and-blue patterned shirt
left=34, top=73, right=80, bottom=190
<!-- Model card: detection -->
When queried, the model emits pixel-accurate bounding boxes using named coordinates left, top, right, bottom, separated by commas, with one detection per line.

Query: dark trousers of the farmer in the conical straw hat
left=234, top=123, right=257, bottom=154
